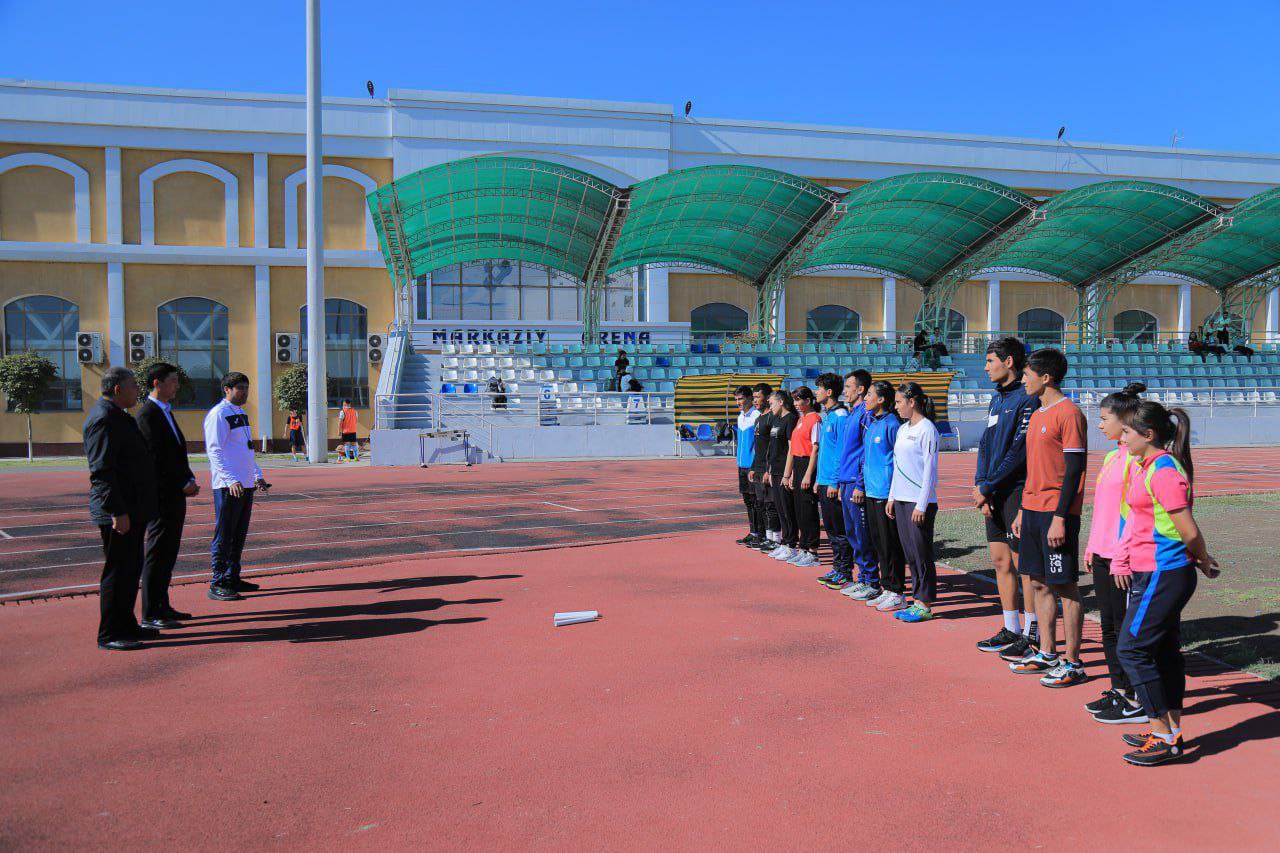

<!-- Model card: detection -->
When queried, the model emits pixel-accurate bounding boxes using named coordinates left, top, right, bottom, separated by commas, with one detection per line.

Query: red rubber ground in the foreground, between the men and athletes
left=0, top=530, right=1280, bottom=850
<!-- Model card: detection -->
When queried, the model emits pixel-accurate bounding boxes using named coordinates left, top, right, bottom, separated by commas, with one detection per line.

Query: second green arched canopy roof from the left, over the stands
left=608, top=165, right=837, bottom=282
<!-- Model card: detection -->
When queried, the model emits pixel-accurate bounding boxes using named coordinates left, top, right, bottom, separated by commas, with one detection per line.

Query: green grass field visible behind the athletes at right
left=936, top=493, right=1280, bottom=680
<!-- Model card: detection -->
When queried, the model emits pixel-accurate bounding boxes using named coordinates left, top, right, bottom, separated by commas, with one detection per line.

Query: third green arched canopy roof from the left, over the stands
left=804, top=172, right=1036, bottom=287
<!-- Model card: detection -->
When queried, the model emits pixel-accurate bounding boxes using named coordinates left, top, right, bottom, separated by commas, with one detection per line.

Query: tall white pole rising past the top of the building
left=307, top=0, right=329, bottom=462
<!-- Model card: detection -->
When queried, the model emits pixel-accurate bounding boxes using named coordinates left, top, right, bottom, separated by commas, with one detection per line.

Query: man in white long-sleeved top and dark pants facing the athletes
left=205, top=371, right=271, bottom=601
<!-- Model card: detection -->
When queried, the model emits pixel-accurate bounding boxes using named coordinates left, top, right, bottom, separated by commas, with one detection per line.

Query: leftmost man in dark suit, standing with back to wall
left=84, top=368, right=160, bottom=651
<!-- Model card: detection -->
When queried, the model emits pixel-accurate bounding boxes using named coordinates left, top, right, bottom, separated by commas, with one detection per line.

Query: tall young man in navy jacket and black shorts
left=973, top=337, right=1039, bottom=661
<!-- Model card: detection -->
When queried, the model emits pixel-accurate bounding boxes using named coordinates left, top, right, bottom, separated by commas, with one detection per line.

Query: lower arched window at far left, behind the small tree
left=4, top=296, right=82, bottom=411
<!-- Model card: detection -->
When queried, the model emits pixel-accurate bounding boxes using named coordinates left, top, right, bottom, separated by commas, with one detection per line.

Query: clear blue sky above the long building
left=0, top=0, right=1280, bottom=152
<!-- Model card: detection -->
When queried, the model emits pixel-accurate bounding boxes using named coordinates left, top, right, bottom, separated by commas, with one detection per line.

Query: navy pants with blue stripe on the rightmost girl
left=1116, top=565, right=1197, bottom=717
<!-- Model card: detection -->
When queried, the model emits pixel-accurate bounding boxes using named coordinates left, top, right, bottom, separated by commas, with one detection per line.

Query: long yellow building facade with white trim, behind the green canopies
left=0, top=81, right=1280, bottom=452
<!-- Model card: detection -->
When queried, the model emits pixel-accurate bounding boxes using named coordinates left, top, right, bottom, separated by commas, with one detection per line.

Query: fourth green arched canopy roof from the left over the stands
left=991, top=181, right=1221, bottom=287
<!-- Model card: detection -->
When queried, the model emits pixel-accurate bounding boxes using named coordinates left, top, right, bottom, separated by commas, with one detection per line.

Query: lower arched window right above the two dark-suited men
left=156, top=296, right=232, bottom=409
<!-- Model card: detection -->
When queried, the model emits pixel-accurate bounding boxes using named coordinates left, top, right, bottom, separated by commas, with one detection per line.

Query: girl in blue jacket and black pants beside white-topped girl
left=863, top=379, right=906, bottom=611
